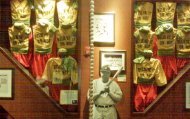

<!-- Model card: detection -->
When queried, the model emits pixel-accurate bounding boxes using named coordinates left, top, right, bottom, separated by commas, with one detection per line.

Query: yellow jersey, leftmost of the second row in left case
left=8, top=24, right=31, bottom=54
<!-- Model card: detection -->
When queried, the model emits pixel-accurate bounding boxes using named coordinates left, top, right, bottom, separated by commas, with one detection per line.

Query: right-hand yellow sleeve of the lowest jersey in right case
left=155, top=61, right=167, bottom=86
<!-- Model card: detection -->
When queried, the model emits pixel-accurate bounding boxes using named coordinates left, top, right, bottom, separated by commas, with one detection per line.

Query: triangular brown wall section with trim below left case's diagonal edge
left=0, top=47, right=80, bottom=119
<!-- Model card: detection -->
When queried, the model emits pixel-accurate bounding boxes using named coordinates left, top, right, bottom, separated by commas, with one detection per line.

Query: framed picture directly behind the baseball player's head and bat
left=99, top=50, right=126, bottom=76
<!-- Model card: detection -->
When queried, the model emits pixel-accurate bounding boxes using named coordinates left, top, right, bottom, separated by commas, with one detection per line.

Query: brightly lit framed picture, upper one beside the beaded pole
left=93, top=13, right=115, bottom=44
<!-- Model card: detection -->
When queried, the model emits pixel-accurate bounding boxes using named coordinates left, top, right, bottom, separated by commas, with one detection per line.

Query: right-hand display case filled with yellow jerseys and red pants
left=132, top=0, right=190, bottom=114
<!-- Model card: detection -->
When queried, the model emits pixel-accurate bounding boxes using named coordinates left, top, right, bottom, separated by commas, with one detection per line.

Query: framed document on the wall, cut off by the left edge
left=0, top=69, right=13, bottom=99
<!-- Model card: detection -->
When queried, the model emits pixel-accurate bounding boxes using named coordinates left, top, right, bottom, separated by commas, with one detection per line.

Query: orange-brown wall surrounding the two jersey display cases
left=0, top=0, right=190, bottom=119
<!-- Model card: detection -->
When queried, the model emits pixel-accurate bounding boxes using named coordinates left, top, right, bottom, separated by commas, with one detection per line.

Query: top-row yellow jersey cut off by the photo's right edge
left=177, top=2, right=190, bottom=28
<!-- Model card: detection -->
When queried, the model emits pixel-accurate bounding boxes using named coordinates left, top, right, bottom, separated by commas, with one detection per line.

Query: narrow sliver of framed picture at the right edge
left=185, top=82, right=190, bottom=109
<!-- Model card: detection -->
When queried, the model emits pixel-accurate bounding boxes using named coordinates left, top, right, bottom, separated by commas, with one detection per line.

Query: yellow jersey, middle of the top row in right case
left=156, top=2, right=176, bottom=26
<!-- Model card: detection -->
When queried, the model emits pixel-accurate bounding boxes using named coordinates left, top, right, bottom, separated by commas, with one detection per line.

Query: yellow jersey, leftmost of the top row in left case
left=10, top=0, right=31, bottom=25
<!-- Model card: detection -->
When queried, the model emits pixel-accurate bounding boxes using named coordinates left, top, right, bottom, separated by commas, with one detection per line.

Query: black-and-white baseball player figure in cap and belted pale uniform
left=87, top=65, right=122, bottom=119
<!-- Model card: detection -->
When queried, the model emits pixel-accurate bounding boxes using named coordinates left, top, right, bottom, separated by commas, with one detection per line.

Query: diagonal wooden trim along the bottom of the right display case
left=133, top=63, right=190, bottom=114
